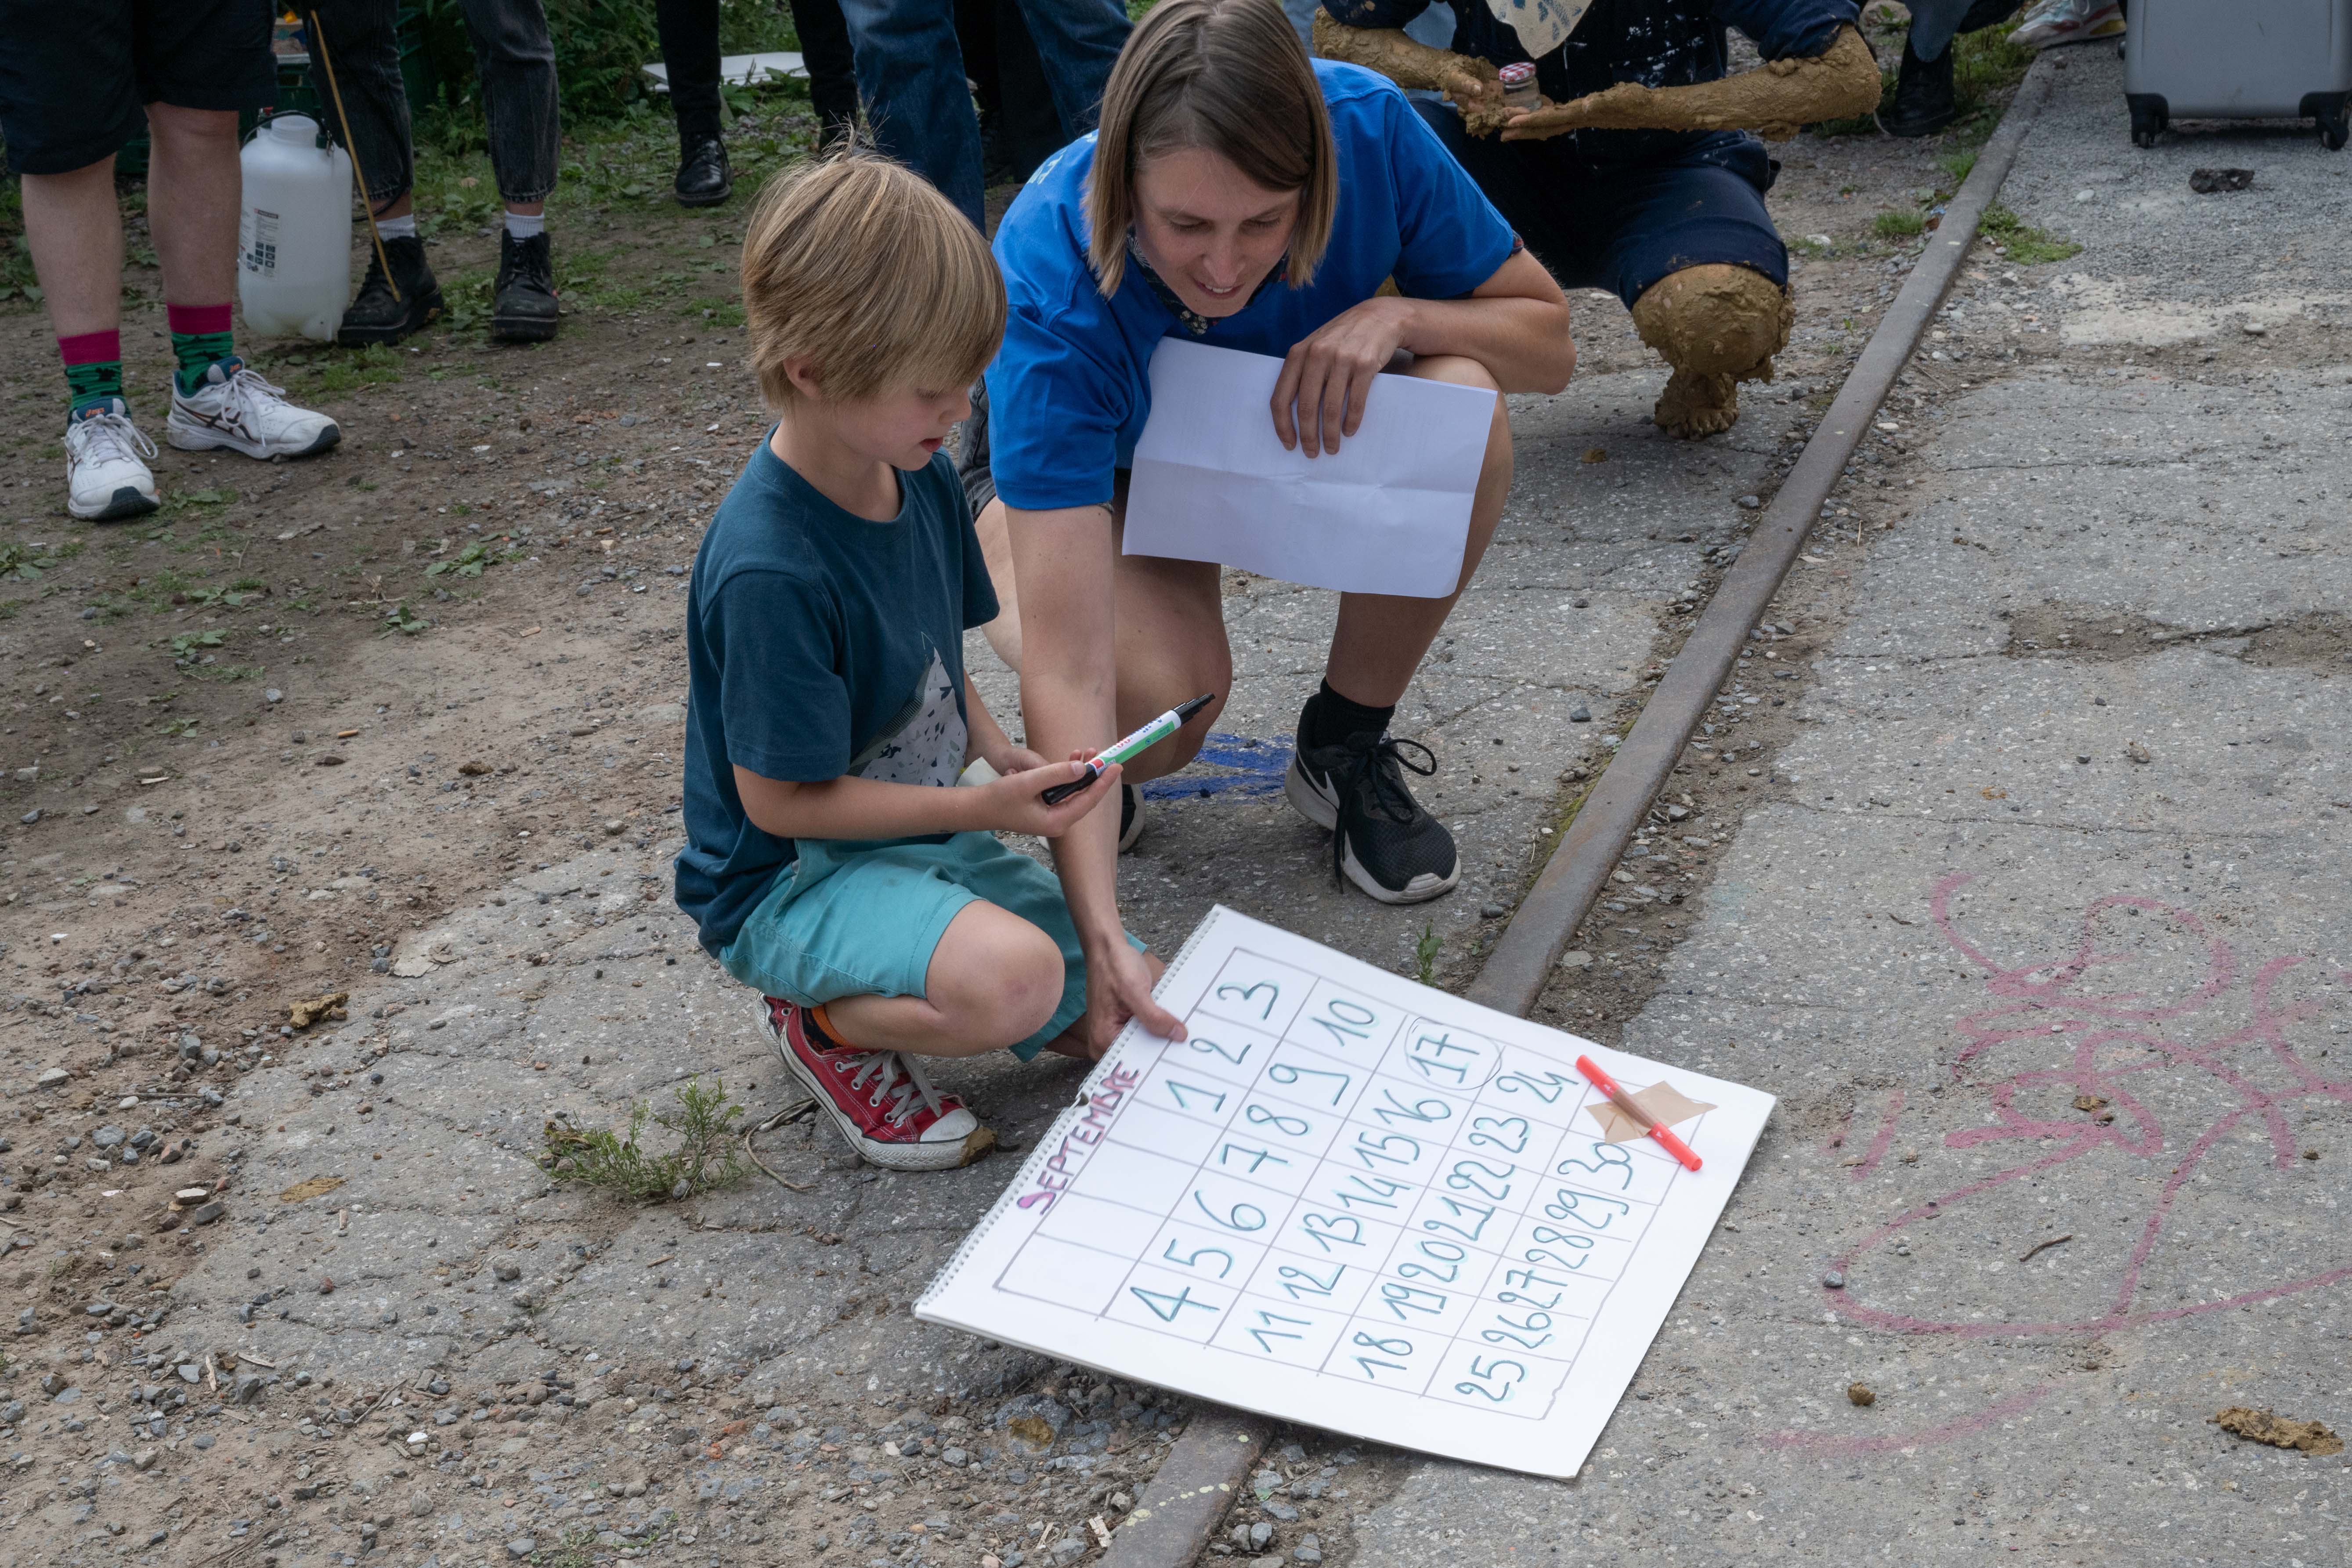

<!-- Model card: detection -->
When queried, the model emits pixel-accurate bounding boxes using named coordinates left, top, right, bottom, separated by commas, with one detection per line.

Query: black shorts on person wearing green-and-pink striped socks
left=0, top=0, right=278, bottom=174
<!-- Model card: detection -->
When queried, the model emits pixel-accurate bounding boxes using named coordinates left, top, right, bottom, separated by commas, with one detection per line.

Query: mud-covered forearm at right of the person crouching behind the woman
left=1505, top=28, right=1879, bottom=141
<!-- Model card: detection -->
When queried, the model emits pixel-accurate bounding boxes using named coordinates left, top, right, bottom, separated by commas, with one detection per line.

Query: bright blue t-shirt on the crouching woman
left=988, top=61, right=1517, bottom=513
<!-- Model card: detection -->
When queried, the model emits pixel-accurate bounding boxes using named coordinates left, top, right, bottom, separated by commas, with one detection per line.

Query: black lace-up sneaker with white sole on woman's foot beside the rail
left=1282, top=698, right=1463, bottom=903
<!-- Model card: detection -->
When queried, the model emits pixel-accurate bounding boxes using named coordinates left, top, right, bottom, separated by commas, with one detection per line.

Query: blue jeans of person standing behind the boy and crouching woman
left=842, top=0, right=1129, bottom=228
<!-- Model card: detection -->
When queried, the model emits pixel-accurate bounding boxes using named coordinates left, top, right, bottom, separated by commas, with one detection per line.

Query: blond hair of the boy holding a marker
left=743, top=148, right=1004, bottom=409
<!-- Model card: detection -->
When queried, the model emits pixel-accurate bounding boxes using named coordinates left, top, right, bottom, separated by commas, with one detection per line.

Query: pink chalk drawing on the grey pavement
left=1823, top=872, right=2352, bottom=1335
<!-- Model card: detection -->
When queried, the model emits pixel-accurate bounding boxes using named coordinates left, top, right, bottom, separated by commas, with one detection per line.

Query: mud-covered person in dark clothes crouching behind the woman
left=1315, top=0, right=1879, bottom=437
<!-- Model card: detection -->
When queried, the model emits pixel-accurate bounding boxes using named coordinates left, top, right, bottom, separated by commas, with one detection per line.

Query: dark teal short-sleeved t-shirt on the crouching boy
left=677, top=440, right=997, bottom=954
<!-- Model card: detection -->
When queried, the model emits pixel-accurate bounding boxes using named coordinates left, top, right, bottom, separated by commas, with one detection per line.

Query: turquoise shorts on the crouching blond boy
left=720, top=832, right=1143, bottom=1062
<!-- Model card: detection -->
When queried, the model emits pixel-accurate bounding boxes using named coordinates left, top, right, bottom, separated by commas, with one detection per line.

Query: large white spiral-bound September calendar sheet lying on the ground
left=915, top=907, right=1774, bottom=1476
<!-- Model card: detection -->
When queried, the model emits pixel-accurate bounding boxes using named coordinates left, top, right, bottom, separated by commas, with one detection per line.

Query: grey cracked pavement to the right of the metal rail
left=1355, top=49, right=2352, bottom=1568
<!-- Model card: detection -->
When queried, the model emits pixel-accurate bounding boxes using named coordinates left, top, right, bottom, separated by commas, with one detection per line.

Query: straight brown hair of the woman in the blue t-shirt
left=1087, top=0, right=1338, bottom=296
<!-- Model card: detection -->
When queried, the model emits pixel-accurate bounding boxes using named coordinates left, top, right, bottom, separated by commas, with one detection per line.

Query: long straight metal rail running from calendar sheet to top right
left=1465, top=54, right=2051, bottom=1018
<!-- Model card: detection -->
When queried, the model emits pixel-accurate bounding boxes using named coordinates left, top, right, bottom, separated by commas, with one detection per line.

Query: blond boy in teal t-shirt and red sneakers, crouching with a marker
left=677, top=153, right=1162, bottom=1171
